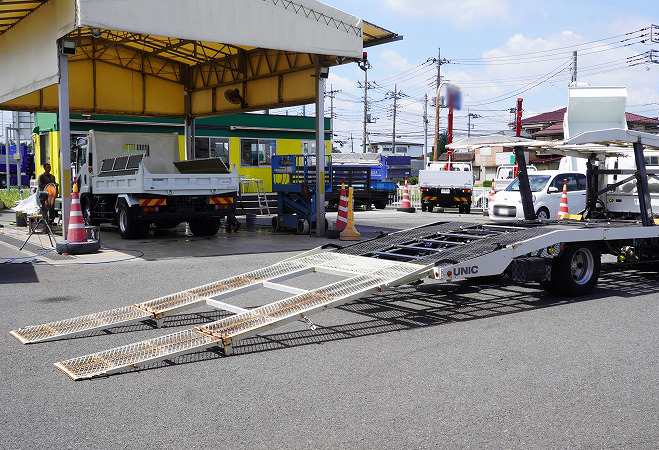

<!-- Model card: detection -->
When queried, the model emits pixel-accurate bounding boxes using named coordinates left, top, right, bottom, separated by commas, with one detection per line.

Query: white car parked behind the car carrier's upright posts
left=488, top=170, right=586, bottom=221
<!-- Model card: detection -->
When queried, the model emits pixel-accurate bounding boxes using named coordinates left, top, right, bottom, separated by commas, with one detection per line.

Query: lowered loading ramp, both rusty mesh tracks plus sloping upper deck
left=12, top=221, right=596, bottom=380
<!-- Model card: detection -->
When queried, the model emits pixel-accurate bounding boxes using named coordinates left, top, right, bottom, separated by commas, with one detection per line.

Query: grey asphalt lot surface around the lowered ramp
left=0, top=207, right=659, bottom=449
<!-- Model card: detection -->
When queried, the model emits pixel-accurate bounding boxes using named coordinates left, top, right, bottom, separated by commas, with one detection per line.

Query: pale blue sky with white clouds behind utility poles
left=278, top=0, right=659, bottom=152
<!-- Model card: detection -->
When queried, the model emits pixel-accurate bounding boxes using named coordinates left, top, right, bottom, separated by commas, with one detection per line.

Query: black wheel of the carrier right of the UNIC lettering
left=545, top=243, right=601, bottom=297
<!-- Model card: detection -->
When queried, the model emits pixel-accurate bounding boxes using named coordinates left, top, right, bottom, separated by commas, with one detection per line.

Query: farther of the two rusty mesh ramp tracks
left=10, top=252, right=408, bottom=344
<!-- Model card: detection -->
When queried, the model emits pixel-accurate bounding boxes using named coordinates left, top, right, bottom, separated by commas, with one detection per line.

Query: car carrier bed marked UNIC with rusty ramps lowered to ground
left=11, top=130, right=659, bottom=380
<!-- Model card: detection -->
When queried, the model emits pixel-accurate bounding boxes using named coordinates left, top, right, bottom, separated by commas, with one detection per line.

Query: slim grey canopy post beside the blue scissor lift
left=316, top=61, right=325, bottom=237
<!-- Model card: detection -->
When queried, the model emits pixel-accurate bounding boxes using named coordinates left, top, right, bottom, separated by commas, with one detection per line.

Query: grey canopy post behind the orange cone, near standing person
left=57, top=46, right=71, bottom=239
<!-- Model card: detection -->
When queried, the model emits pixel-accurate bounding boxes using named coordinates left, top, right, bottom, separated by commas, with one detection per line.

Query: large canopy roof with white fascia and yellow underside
left=0, top=0, right=401, bottom=117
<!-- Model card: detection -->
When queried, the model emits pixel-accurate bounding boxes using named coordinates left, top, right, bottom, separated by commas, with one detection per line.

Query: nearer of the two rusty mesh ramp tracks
left=55, top=255, right=428, bottom=380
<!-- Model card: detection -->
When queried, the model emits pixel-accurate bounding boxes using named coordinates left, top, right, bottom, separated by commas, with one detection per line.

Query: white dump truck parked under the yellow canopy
left=73, top=130, right=238, bottom=239
